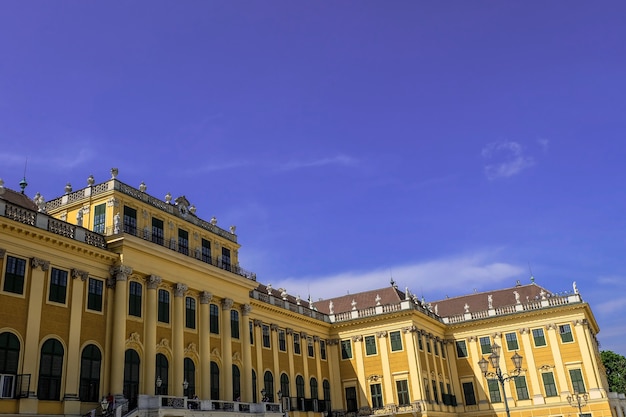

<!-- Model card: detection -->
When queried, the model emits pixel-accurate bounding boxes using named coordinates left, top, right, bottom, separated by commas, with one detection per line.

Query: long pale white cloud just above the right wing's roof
left=271, top=251, right=525, bottom=300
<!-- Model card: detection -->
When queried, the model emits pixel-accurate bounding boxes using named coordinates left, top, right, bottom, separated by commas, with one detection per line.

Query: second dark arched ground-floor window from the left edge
left=37, top=339, right=64, bottom=401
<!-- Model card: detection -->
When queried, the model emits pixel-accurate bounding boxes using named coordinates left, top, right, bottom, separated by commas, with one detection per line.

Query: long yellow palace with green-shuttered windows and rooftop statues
left=0, top=169, right=626, bottom=417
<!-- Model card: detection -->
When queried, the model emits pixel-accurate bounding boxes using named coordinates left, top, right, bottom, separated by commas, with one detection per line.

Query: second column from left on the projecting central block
left=143, top=275, right=162, bottom=395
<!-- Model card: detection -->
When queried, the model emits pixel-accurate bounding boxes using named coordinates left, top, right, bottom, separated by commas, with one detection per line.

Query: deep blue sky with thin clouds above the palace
left=0, top=0, right=626, bottom=354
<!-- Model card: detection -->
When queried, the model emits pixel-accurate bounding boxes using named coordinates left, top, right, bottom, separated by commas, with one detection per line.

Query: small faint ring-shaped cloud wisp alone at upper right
left=482, top=141, right=535, bottom=180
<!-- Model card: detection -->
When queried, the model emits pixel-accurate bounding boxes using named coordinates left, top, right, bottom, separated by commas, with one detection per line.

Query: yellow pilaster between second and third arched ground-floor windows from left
left=64, top=269, right=89, bottom=414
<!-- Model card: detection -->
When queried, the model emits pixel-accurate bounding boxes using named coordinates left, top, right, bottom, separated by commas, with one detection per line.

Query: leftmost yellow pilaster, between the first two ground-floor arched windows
left=20, top=258, right=50, bottom=414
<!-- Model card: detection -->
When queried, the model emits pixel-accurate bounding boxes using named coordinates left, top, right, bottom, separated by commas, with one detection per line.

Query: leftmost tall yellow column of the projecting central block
left=111, top=265, right=133, bottom=399
